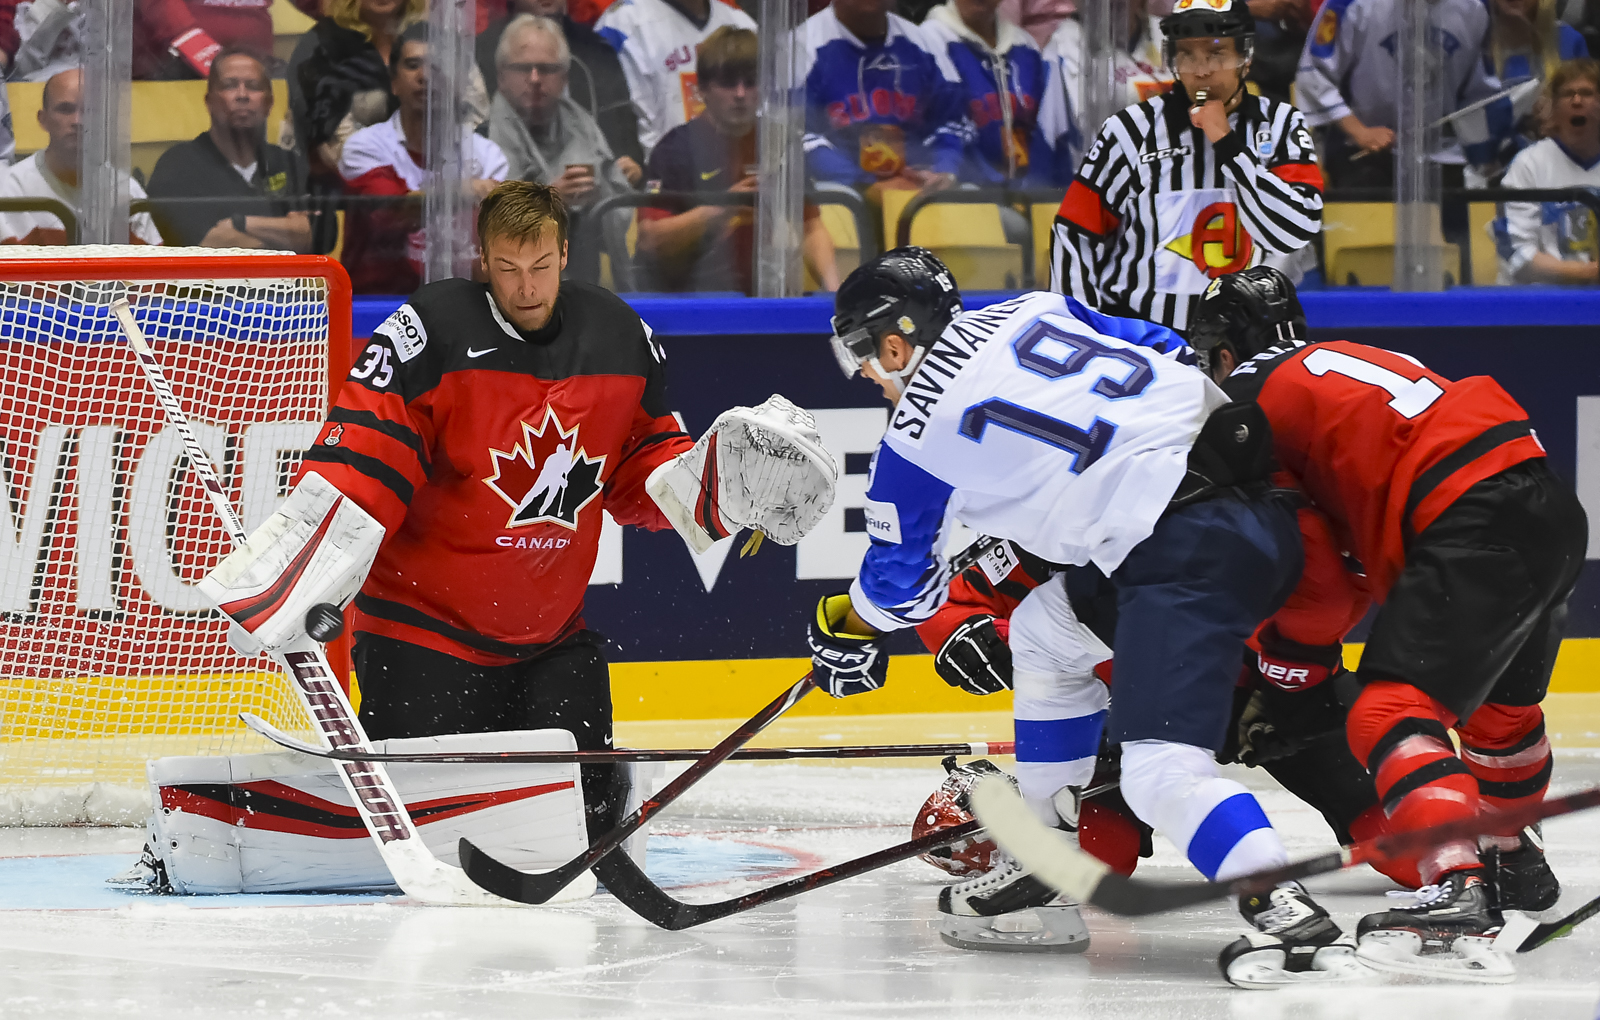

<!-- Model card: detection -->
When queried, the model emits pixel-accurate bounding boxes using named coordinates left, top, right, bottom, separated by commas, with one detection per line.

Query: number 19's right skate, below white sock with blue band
left=1216, top=883, right=1365, bottom=988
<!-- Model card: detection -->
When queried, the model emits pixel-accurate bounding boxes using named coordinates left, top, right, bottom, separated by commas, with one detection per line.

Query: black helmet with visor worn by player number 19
left=834, top=245, right=962, bottom=376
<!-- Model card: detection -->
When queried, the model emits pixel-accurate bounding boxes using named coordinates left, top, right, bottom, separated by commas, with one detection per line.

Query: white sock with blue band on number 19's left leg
left=1010, top=574, right=1110, bottom=828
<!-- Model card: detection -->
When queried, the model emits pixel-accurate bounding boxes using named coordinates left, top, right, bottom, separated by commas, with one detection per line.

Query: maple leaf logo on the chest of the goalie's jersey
left=483, top=406, right=605, bottom=531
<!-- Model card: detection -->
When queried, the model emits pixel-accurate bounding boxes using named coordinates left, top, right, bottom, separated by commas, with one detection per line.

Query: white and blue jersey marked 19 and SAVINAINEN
left=850, top=293, right=1227, bottom=630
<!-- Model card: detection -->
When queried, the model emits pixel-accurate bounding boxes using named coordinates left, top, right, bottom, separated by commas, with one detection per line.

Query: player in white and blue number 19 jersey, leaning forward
left=810, top=248, right=1350, bottom=974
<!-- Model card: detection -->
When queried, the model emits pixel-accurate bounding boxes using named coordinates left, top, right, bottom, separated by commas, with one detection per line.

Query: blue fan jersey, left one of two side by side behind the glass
left=805, top=5, right=973, bottom=185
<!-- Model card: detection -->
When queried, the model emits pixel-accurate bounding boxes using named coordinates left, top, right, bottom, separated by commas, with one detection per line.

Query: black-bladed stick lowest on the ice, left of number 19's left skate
left=595, top=820, right=982, bottom=932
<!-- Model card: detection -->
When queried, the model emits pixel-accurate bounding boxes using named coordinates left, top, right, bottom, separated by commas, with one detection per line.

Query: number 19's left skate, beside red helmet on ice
left=939, top=851, right=1090, bottom=953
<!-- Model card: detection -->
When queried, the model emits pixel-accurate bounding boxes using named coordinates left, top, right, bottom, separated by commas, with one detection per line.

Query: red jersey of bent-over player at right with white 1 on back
left=1222, top=341, right=1544, bottom=601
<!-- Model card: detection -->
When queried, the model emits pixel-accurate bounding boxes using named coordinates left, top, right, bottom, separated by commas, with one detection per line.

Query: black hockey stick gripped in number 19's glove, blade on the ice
left=461, top=673, right=816, bottom=903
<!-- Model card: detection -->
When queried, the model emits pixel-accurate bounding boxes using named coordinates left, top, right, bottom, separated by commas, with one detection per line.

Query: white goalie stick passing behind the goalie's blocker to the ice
left=110, top=299, right=560, bottom=905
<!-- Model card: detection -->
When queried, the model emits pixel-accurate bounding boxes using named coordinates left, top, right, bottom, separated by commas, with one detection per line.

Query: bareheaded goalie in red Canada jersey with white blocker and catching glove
left=208, top=181, right=837, bottom=831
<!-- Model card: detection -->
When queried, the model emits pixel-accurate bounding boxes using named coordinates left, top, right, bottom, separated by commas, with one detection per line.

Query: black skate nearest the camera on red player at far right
left=1355, top=868, right=1517, bottom=985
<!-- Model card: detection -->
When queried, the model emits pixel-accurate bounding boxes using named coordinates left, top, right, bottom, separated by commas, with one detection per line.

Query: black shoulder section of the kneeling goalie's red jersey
left=374, top=280, right=661, bottom=398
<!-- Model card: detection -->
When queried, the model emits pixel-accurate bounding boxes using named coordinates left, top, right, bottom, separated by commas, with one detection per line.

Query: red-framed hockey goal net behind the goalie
left=0, top=246, right=350, bottom=825
